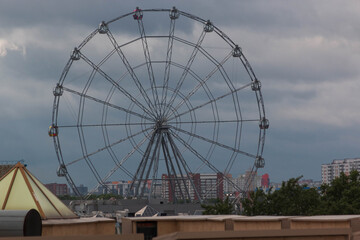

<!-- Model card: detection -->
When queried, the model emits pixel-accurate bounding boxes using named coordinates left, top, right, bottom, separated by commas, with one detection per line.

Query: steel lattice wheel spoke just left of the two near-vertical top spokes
left=102, top=30, right=156, bottom=117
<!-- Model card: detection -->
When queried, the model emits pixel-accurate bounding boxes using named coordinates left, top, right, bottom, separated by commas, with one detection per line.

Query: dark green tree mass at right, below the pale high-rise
left=241, top=171, right=360, bottom=216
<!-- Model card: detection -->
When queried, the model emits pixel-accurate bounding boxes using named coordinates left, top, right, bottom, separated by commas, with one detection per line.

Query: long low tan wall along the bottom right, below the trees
left=123, top=215, right=360, bottom=239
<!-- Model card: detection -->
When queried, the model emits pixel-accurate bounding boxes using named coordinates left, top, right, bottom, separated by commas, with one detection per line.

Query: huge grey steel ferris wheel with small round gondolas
left=49, top=7, right=269, bottom=201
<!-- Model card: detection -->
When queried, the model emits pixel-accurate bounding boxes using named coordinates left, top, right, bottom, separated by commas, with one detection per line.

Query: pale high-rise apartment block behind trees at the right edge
left=321, top=158, right=360, bottom=184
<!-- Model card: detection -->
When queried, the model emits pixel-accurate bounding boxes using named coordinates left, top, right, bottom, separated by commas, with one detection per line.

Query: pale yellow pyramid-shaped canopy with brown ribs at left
left=0, top=163, right=77, bottom=219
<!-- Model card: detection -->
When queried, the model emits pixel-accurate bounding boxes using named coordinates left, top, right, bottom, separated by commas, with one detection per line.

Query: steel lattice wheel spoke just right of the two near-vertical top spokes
left=164, top=30, right=206, bottom=116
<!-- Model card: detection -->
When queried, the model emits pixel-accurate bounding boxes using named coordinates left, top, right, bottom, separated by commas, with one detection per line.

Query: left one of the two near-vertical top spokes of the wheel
left=137, top=18, right=160, bottom=114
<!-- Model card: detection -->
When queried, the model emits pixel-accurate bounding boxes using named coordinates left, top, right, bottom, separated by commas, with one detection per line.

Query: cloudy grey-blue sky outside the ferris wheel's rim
left=0, top=0, right=360, bottom=186
